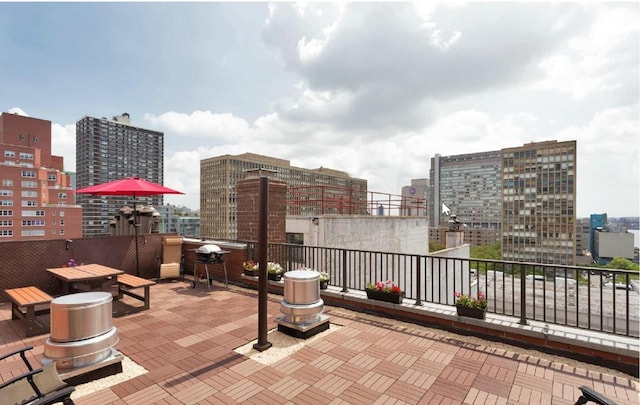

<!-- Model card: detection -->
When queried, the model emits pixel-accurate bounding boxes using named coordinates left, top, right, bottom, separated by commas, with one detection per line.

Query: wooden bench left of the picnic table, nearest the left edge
left=4, top=286, right=53, bottom=336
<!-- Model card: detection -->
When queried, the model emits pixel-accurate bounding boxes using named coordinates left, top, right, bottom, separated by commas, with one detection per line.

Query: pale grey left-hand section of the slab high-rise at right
left=429, top=151, right=501, bottom=230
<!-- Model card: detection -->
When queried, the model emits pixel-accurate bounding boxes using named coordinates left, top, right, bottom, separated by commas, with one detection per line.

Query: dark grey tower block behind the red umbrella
left=76, top=113, right=164, bottom=238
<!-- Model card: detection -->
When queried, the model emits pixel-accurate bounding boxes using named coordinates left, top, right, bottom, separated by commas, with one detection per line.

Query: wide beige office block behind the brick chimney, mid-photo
left=200, top=153, right=367, bottom=239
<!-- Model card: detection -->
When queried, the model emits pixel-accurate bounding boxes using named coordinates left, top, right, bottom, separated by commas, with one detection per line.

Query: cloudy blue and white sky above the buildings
left=0, top=1, right=640, bottom=217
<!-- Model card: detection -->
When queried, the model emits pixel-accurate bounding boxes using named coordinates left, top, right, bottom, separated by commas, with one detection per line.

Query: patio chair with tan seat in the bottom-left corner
left=0, top=346, right=75, bottom=405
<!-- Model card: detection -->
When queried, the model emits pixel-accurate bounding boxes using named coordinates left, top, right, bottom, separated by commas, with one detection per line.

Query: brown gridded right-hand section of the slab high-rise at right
left=501, top=141, right=576, bottom=265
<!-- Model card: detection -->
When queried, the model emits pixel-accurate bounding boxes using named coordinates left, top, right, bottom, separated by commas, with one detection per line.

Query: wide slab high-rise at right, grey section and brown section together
left=429, top=141, right=576, bottom=265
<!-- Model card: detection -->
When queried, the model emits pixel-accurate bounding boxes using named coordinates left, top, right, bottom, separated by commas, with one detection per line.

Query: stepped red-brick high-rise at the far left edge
left=0, top=113, right=82, bottom=241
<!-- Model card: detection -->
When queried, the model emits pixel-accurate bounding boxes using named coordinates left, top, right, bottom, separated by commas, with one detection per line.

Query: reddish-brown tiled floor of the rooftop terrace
left=0, top=282, right=640, bottom=405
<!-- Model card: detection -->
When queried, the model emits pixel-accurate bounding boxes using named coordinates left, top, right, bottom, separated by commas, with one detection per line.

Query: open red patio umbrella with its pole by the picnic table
left=74, top=176, right=184, bottom=276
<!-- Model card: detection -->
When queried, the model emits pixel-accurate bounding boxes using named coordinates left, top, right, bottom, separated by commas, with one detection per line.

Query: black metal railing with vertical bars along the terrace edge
left=247, top=242, right=640, bottom=336
